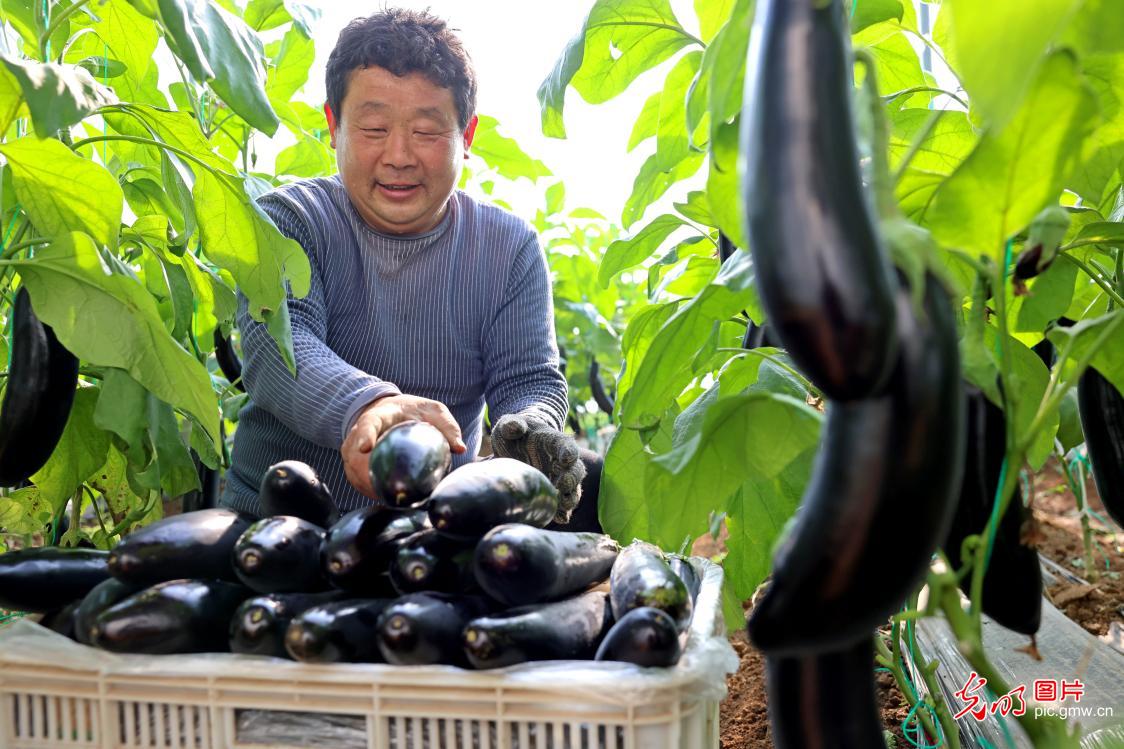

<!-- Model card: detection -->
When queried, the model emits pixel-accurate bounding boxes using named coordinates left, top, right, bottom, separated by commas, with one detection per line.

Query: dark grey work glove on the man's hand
left=491, top=413, right=586, bottom=524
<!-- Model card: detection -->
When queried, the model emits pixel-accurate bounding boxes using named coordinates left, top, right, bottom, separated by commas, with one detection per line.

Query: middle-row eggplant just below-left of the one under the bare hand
left=320, top=505, right=429, bottom=597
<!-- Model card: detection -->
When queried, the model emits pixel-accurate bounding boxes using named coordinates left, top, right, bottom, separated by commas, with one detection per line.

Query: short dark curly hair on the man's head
left=325, top=8, right=477, bottom=130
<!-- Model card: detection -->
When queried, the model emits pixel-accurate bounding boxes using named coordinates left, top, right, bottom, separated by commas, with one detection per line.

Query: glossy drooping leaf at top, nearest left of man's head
left=157, top=0, right=280, bottom=135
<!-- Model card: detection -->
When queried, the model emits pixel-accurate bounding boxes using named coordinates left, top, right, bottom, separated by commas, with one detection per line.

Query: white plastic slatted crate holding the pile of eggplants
left=0, top=558, right=737, bottom=749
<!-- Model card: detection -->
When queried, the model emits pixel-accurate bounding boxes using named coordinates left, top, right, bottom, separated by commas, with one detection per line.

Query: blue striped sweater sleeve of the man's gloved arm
left=483, top=234, right=569, bottom=431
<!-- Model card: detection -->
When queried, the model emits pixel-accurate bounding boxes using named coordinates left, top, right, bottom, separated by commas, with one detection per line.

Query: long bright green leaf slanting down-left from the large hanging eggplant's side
left=617, top=250, right=761, bottom=428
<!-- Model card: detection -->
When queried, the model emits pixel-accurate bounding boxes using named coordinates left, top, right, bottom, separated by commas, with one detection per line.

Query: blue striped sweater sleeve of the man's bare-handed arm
left=237, top=201, right=400, bottom=449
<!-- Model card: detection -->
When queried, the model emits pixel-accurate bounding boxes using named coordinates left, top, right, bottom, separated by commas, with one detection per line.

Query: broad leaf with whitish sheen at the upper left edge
left=0, top=56, right=116, bottom=138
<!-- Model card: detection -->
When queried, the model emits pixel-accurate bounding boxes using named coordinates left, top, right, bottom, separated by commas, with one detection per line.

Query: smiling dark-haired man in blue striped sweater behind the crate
left=223, top=9, right=600, bottom=530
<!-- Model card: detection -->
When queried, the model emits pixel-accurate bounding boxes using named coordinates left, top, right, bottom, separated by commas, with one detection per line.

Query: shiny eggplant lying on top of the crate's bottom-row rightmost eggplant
left=609, top=541, right=691, bottom=630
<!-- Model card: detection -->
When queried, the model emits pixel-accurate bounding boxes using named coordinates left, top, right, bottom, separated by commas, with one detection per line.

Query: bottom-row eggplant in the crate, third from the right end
left=375, top=593, right=491, bottom=667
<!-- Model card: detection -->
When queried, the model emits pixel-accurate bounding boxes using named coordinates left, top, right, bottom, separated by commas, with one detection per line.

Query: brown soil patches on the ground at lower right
left=710, top=462, right=1124, bottom=749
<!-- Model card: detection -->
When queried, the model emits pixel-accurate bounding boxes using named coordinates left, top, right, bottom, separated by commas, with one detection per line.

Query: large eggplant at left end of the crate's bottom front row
left=90, top=573, right=252, bottom=655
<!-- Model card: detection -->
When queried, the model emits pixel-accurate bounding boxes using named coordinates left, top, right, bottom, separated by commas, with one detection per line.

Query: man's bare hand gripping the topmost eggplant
left=339, top=395, right=466, bottom=499
